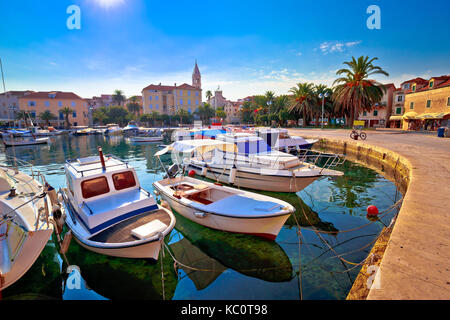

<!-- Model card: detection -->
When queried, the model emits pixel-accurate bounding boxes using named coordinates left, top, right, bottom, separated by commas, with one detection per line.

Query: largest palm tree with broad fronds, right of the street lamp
left=333, top=56, right=389, bottom=125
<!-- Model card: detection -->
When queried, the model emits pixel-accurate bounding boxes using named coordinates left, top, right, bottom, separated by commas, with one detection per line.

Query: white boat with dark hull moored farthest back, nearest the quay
left=255, top=128, right=319, bottom=152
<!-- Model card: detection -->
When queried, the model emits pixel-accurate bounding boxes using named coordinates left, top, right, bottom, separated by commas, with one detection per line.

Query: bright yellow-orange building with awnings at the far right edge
left=402, top=75, right=450, bottom=130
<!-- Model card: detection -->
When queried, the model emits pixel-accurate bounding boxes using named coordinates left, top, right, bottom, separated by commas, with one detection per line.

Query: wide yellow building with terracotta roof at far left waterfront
left=19, top=91, right=89, bottom=127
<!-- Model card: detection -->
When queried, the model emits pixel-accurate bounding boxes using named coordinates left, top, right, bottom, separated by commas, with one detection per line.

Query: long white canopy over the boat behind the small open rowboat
left=155, top=139, right=237, bottom=157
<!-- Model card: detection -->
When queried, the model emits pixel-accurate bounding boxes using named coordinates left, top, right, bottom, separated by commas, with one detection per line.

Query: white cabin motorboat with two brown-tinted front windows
left=60, top=148, right=176, bottom=260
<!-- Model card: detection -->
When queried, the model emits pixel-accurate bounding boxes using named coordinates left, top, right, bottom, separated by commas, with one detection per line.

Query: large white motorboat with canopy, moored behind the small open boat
left=160, top=134, right=343, bottom=192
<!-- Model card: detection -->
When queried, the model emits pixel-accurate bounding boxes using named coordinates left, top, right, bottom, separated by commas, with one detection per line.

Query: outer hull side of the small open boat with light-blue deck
left=153, top=183, right=290, bottom=240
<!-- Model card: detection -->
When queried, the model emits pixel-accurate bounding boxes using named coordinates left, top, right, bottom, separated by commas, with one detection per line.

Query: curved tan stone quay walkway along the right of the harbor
left=289, top=129, right=450, bottom=300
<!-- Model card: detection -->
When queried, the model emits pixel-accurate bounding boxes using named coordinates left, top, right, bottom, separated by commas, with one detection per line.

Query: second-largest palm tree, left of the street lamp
left=288, top=82, right=317, bottom=126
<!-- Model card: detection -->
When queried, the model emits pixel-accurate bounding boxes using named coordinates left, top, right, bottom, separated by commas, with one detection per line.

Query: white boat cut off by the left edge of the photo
left=0, top=161, right=53, bottom=291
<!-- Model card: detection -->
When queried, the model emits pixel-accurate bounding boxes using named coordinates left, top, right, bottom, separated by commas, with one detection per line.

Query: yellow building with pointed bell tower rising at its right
left=142, top=62, right=202, bottom=115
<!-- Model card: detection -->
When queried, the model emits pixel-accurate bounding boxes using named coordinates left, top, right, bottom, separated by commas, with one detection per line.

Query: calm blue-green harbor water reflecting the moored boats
left=0, top=136, right=401, bottom=300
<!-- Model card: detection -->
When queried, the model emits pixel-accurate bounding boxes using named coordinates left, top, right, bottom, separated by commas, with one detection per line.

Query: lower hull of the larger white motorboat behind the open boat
left=188, top=164, right=320, bottom=192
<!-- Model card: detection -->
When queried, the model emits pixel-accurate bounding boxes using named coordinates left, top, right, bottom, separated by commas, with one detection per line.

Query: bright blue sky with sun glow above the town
left=0, top=0, right=450, bottom=99
